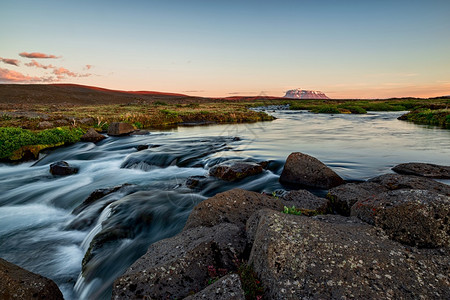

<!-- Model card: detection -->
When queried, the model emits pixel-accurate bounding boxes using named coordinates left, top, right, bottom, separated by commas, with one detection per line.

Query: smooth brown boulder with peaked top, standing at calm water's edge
left=280, top=152, right=344, bottom=189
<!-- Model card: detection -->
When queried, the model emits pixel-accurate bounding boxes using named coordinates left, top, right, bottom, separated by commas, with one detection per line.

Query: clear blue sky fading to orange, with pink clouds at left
left=0, top=0, right=450, bottom=98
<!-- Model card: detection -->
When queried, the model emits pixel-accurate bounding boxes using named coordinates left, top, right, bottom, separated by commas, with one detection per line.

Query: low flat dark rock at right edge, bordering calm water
left=392, top=163, right=450, bottom=179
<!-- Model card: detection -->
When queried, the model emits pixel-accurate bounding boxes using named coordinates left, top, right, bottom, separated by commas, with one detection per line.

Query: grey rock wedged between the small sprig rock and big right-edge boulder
left=327, top=182, right=389, bottom=216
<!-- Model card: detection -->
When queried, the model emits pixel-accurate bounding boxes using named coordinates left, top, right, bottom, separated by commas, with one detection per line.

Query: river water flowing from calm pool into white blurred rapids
left=0, top=111, right=450, bottom=299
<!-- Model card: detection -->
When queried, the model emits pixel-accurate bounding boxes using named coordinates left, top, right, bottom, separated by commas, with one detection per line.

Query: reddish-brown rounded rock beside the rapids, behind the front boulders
left=184, top=189, right=284, bottom=230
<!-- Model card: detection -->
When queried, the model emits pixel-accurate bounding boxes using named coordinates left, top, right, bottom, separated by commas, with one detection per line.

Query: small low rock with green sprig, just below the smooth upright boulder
left=281, top=190, right=331, bottom=215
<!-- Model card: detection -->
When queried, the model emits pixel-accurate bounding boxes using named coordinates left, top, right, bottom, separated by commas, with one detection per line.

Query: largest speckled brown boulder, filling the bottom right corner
left=249, top=211, right=450, bottom=299
